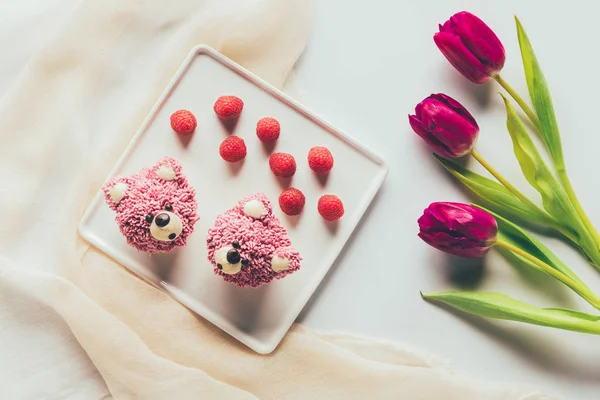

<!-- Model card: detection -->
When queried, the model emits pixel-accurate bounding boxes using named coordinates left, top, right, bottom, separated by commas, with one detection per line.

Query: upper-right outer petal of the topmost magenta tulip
left=449, top=11, right=506, bottom=75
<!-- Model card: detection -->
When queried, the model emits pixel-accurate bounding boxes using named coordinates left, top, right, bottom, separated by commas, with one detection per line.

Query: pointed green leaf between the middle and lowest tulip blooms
left=435, top=155, right=556, bottom=226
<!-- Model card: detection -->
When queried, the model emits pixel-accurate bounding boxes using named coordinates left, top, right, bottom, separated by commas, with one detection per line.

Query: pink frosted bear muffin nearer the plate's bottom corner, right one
left=206, top=193, right=302, bottom=287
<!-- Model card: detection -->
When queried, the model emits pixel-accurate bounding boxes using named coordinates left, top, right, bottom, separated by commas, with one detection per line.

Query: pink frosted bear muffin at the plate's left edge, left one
left=102, top=157, right=199, bottom=254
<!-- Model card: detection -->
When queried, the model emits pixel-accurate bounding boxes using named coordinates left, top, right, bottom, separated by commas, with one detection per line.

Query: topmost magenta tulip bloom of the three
left=433, top=11, right=506, bottom=83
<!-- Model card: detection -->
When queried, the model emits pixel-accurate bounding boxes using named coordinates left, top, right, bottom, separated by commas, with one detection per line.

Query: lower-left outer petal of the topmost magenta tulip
left=433, top=32, right=489, bottom=83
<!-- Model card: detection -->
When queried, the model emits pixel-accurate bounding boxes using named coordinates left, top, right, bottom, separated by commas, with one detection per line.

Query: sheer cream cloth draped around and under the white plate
left=0, top=0, right=543, bottom=400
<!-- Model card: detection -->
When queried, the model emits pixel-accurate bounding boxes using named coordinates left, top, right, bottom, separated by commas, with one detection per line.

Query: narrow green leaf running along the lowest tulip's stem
left=474, top=204, right=585, bottom=286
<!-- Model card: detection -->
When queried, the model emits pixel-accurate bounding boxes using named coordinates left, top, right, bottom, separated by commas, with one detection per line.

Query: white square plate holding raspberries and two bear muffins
left=79, top=46, right=387, bottom=354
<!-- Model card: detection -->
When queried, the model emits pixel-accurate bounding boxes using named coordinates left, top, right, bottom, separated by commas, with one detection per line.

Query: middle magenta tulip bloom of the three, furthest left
left=408, top=94, right=479, bottom=158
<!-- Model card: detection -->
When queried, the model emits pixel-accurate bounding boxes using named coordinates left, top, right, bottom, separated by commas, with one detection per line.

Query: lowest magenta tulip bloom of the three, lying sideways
left=418, top=203, right=498, bottom=258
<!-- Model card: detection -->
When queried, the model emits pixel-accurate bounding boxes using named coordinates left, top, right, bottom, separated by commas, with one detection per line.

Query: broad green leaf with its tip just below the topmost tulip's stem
left=502, top=95, right=578, bottom=228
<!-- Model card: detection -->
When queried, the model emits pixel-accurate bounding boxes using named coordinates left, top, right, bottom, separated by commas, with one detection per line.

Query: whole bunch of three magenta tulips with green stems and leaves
left=409, top=12, right=600, bottom=334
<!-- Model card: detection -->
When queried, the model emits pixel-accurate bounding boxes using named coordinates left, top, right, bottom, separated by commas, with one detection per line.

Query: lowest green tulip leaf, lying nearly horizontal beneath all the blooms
left=422, top=292, right=600, bottom=335
